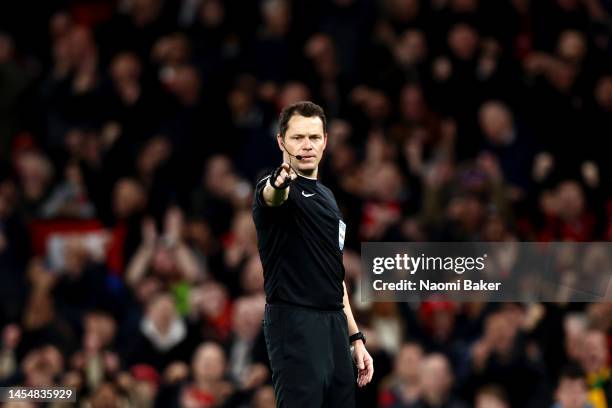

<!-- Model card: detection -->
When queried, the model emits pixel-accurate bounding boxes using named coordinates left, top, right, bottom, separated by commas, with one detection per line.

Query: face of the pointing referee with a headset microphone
left=277, top=114, right=327, bottom=173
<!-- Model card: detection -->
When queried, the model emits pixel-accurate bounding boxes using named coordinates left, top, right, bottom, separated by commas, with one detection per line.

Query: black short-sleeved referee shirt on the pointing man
left=253, top=172, right=346, bottom=310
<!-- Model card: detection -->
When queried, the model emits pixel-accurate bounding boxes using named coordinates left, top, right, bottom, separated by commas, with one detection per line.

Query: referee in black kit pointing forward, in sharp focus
left=253, top=102, right=374, bottom=408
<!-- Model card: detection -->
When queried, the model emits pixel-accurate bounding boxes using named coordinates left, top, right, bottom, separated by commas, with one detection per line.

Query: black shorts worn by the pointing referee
left=264, top=305, right=356, bottom=408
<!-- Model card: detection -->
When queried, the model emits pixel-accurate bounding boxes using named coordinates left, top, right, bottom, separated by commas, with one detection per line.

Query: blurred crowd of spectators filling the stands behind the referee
left=0, top=0, right=612, bottom=408
